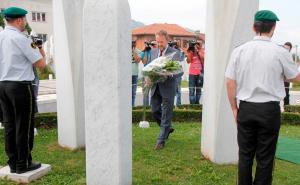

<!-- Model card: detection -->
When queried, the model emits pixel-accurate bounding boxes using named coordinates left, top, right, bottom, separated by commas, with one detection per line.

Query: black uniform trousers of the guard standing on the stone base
left=0, top=81, right=34, bottom=169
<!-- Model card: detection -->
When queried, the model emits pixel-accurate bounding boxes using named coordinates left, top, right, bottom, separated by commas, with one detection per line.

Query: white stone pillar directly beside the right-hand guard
left=201, top=0, right=258, bottom=164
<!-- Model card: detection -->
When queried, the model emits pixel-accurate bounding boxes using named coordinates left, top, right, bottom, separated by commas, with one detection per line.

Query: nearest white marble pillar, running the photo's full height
left=83, top=0, right=132, bottom=185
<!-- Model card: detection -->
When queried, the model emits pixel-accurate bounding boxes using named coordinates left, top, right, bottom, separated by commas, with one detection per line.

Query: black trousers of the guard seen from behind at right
left=237, top=101, right=280, bottom=185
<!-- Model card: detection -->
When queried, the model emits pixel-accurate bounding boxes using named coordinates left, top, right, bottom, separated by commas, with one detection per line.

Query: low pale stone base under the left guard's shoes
left=0, top=164, right=51, bottom=183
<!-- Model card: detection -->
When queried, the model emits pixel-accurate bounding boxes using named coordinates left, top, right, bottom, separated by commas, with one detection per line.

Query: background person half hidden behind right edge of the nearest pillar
left=131, top=41, right=141, bottom=107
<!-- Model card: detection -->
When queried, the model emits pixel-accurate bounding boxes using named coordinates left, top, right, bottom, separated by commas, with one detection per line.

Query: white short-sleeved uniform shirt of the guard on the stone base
left=0, top=26, right=42, bottom=81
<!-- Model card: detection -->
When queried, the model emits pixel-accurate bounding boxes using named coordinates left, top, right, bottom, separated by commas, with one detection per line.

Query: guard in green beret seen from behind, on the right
left=225, top=10, right=300, bottom=185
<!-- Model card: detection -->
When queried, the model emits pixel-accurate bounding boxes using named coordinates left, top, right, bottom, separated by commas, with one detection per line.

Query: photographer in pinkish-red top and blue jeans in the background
left=186, top=41, right=204, bottom=104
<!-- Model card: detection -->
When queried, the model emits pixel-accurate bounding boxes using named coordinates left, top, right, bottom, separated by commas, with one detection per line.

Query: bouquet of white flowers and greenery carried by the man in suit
left=143, top=53, right=183, bottom=87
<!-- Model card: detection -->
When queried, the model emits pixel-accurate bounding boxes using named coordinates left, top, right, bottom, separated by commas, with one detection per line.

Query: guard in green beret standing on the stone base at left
left=0, top=7, right=45, bottom=174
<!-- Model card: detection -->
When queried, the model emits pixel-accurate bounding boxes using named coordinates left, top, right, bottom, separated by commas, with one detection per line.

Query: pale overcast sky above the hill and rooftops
left=129, top=0, right=300, bottom=51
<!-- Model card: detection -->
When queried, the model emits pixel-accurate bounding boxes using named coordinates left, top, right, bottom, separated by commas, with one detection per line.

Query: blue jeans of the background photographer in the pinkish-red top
left=189, top=75, right=201, bottom=104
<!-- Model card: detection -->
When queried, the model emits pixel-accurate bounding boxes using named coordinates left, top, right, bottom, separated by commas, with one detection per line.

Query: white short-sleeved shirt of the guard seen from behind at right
left=225, top=36, right=299, bottom=102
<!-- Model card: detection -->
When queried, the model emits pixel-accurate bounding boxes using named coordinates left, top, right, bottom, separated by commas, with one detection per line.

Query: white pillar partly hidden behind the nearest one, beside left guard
left=53, top=0, right=85, bottom=149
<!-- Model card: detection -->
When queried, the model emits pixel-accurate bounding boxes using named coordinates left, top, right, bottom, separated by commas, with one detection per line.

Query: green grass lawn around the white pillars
left=0, top=123, right=300, bottom=185
